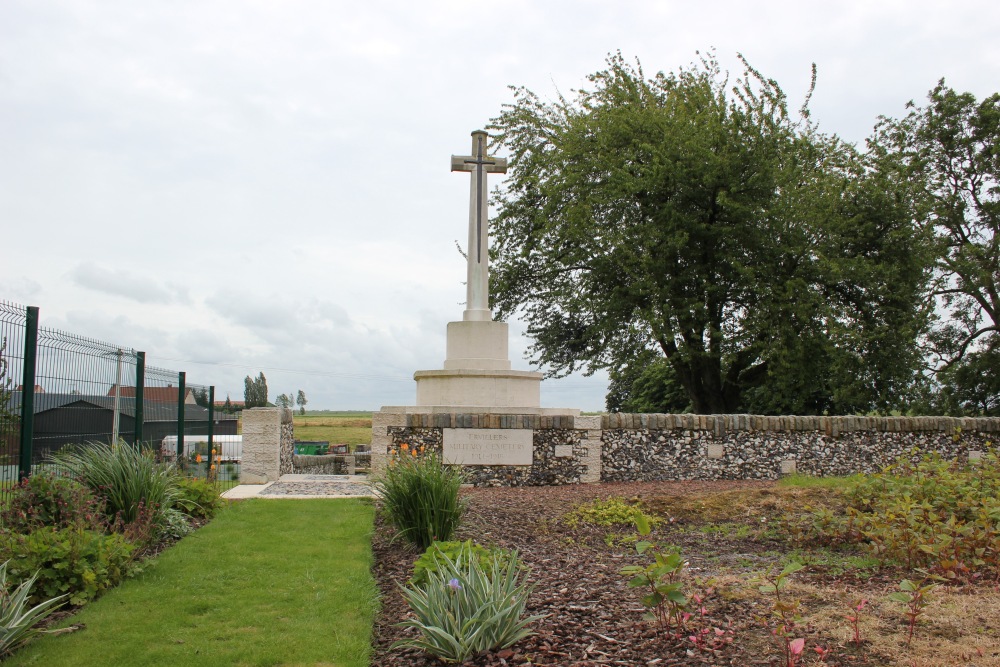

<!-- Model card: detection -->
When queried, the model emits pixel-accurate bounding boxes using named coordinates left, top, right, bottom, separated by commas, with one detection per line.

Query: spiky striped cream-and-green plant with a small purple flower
left=393, top=548, right=542, bottom=662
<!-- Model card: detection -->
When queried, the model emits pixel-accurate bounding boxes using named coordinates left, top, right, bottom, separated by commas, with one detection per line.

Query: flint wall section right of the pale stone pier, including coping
left=601, top=414, right=1000, bottom=481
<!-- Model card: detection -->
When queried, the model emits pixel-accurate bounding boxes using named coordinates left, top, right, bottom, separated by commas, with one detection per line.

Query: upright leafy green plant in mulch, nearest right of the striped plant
left=621, top=513, right=688, bottom=630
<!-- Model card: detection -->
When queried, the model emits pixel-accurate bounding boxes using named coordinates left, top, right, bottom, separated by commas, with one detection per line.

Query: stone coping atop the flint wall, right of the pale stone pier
left=601, top=412, right=1000, bottom=437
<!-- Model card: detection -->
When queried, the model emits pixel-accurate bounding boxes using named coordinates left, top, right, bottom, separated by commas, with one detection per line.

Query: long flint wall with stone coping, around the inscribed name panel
left=372, top=412, right=1000, bottom=486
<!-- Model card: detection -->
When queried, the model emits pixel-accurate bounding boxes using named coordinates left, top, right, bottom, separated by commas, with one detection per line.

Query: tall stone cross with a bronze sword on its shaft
left=451, top=130, right=507, bottom=322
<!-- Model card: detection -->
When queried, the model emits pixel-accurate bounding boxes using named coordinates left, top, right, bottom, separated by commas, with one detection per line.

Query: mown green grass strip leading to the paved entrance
left=4, top=499, right=378, bottom=667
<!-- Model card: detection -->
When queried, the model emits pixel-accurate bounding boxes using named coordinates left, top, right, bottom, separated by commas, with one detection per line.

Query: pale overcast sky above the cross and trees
left=0, top=0, right=1000, bottom=410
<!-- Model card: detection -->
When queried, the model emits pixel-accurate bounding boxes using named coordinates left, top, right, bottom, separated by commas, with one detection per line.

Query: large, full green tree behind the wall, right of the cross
left=491, top=54, right=926, bottom=413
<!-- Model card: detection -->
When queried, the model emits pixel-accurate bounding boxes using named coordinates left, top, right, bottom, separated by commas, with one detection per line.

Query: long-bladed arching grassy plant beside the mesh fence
left=51, top=442, right=180, bottom=524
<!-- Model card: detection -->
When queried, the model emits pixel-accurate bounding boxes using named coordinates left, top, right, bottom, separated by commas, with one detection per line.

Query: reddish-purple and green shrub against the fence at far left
left=0, top=473, right=104, bottom=533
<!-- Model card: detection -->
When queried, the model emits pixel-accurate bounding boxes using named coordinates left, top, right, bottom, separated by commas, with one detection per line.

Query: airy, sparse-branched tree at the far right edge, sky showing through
left=871, top=79, right=1000, bottom=374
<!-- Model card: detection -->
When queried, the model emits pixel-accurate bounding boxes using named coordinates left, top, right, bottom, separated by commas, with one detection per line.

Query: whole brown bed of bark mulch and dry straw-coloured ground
left=372, top=481, right=1000, bottom=667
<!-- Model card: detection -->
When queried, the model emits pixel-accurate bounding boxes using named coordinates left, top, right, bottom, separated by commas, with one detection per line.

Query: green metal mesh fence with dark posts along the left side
left=0, top=301, right=242, bottom=496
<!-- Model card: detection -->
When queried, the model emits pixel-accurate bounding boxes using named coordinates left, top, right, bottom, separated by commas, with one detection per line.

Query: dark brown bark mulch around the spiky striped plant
left=372, top=481, right=879, bottom=667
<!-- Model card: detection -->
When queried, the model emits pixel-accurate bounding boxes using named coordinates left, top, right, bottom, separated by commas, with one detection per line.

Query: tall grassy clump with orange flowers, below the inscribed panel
left=373, top=445, right=465, bottom=549
